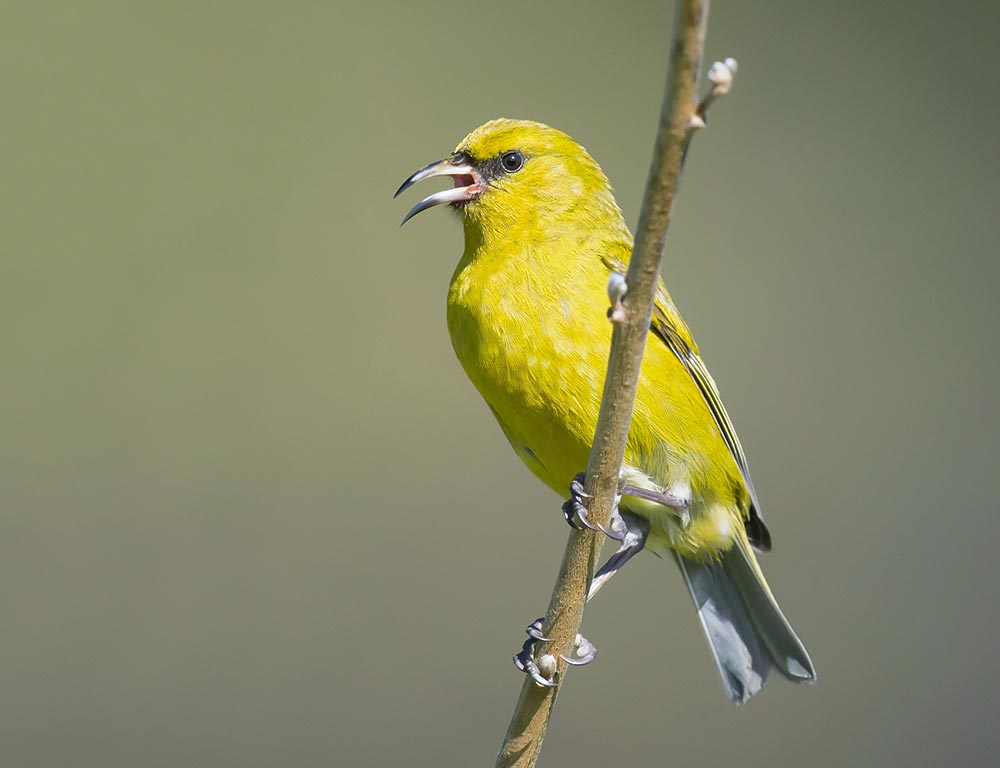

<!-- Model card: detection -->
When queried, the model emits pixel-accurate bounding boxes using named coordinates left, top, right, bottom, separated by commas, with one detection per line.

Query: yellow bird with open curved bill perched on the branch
left=396, top=119, right=815, bottom=702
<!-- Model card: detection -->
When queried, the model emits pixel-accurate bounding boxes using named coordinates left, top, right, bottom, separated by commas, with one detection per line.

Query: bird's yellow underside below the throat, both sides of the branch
left=448, top=242, right=741, bottom=555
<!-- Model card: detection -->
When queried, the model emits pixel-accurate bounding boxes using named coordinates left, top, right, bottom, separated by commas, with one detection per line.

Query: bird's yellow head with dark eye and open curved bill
left=396, top=119, right=624, bottom=236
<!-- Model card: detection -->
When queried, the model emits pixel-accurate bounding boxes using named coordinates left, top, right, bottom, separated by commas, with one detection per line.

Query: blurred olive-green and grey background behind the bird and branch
left=0, top=0, right=1000, bottom=767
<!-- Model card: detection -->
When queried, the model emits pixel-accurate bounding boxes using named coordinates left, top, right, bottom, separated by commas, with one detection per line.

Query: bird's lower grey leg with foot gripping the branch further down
left=514, top=512, right=649, bottom=688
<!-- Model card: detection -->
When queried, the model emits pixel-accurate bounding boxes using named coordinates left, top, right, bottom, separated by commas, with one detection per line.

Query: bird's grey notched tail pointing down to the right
left=674, top=541, right=816, bottom=704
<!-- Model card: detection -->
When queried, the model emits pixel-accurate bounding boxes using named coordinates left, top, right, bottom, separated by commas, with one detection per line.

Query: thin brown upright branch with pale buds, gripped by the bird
left=496, top=0, right=735, bottom=768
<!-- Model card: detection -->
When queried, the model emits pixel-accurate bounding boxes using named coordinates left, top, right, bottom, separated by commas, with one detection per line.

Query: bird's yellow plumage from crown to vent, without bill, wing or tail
left=448, top=120, right=749, bottom=555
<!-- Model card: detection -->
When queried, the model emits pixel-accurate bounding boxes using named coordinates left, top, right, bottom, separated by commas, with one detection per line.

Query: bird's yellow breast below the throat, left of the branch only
left=448, top=242, right=611, bottom=485
